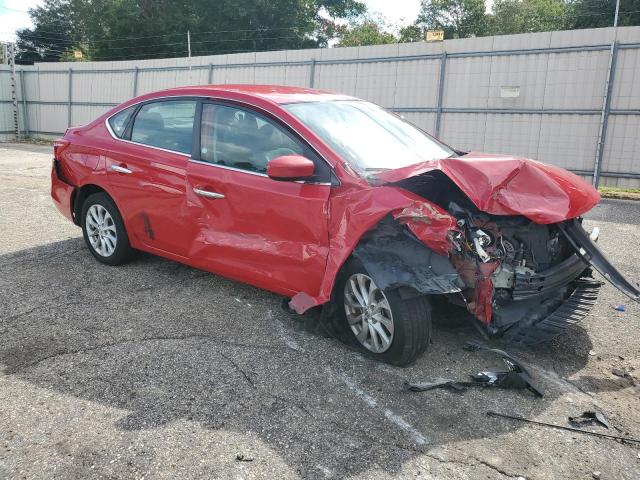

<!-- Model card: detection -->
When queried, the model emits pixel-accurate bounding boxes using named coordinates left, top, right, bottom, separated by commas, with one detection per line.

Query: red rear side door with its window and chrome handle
left=106, top=98, right=197, bottom=256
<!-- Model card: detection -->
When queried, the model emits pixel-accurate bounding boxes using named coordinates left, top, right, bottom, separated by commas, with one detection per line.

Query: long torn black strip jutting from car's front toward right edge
left=558, top=220, right=640, bottom=302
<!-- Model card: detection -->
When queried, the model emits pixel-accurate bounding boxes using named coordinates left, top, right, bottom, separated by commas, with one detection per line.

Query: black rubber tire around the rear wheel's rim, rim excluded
left=80, top=192, right=133, bottom=266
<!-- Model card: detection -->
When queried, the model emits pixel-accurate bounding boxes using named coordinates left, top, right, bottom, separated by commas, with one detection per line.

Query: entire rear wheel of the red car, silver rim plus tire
left=80, top=193, right=133, bottom=265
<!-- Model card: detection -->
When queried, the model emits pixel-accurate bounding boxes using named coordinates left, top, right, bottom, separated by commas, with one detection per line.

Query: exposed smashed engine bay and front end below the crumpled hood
left=354, top=171, right=640, bottom=344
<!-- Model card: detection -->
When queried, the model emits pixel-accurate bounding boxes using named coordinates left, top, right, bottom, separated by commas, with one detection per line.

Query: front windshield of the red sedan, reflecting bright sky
left=283, top=100, right=455, bottom=176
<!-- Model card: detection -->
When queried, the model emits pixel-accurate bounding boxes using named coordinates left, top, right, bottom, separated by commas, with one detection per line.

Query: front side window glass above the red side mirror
left=200, top=103, right=308, bottom=173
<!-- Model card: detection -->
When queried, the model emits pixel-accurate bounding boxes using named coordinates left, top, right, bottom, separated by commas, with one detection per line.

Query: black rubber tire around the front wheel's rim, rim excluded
left=333, top=258, right=431, bottom=367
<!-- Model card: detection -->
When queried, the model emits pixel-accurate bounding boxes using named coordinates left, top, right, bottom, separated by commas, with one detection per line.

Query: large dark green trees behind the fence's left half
left=17, top=0, right=366, bottom=61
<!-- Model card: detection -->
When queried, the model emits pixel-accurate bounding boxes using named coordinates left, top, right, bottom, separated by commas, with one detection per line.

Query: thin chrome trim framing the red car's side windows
left=104, top=95, right=341, bottom=186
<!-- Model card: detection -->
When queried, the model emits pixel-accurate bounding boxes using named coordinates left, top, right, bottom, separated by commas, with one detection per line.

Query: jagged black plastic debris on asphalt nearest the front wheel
left=404, top=342, right=543, bottom=397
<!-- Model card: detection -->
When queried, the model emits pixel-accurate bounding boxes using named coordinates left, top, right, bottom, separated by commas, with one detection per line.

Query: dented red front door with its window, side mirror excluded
left=186, top=102, right=331, bottom=295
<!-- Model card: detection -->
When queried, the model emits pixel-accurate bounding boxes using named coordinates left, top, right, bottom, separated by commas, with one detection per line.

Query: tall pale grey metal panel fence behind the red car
left=0, top=27, right=640, bottom=186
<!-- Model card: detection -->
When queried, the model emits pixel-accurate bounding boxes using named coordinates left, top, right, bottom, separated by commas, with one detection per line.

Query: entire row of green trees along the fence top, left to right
left=17, top=0, right=640, bottom=63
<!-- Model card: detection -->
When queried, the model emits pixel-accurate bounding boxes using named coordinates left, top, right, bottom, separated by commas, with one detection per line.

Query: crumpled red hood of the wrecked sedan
left=375, top=152, right=600, bottom=224
